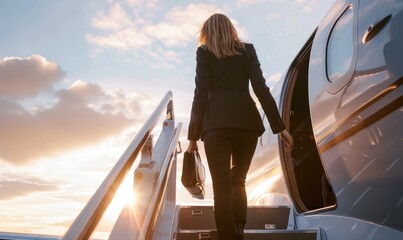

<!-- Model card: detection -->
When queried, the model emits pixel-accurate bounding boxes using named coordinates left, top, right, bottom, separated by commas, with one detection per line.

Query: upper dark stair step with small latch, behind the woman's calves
left=178, top=206, right=290, bottom=230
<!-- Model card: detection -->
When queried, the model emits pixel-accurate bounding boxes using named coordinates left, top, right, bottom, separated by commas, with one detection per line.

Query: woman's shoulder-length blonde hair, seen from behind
left=199, top=13, right=245, bottom=58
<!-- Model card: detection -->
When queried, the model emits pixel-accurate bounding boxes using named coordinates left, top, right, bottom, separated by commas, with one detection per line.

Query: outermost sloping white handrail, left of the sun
left=62, top=91, right=173, bottom=240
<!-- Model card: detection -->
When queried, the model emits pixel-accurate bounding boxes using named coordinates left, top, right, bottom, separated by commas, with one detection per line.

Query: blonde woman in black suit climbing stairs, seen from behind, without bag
left=187, top=14, right=293, bottom=240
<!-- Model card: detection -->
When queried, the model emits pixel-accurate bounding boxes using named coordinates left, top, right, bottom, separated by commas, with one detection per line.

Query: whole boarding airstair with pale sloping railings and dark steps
left=0, top=92, right=326, bottom=240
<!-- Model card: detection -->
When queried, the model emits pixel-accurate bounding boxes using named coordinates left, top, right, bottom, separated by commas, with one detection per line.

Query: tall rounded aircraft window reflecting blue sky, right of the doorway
left=326, top=6, right=354, bottom=82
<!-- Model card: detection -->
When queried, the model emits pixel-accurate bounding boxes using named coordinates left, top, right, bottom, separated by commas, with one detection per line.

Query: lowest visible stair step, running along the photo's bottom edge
left=175, top=230, right=317, bottom=240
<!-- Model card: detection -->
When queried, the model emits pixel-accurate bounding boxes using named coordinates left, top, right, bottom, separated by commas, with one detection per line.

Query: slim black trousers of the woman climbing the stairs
left=203, top=129, right=258, bottom=240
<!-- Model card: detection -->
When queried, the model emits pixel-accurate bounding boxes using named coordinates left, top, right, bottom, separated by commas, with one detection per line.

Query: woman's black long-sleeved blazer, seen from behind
left=188, top=44, right=284, bottom=140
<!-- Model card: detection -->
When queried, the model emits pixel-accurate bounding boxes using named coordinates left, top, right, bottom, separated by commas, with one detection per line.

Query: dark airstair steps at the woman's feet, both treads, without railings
left=174, top=206, right=323, bottom=240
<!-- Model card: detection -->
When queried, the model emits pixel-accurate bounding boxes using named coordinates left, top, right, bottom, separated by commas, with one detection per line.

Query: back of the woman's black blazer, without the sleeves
left=197, top=44, right=264, bottom=137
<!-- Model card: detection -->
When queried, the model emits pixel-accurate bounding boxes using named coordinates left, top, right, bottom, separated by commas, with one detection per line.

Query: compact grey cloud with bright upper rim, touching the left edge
left=0, top=55, right=65, bottom=99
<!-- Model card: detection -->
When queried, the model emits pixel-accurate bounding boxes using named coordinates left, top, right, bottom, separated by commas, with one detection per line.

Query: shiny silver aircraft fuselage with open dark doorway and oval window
left=251, top=0, right=403, bottom=239
